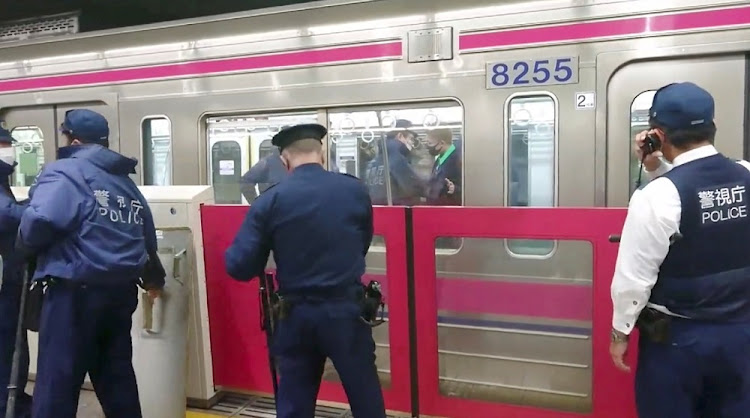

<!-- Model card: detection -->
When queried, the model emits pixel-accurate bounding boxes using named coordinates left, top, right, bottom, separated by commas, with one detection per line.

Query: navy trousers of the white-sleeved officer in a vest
left=635, top=319, right=750, bottom=418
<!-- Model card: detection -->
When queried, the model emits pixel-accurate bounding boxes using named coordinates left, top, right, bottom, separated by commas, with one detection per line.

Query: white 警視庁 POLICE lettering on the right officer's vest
left=698, top=184, right=747, bottom=225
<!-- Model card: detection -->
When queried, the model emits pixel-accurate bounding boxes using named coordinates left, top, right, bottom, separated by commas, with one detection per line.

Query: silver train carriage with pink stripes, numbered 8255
left=0, top=0, right=750, bottom=412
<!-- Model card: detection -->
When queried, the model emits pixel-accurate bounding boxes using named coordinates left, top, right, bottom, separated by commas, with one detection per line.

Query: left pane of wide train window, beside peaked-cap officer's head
left=206, top=112, right=318, bottom=204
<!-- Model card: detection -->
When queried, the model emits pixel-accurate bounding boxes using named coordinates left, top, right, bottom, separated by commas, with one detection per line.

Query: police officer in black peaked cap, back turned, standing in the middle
left=226, top=124, right=385, bottom=418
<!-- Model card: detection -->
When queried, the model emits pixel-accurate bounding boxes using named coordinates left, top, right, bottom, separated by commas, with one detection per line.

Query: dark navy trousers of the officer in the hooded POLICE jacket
left=33, top=283, right=141, bottom=418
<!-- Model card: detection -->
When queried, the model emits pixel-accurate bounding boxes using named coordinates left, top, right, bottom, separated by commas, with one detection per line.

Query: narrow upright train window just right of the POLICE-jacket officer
left=141, top=116, right=172, bottom=186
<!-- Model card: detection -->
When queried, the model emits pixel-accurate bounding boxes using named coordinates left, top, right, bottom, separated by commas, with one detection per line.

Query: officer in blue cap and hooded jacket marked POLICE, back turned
left=18, top=109, right=165, bottom=418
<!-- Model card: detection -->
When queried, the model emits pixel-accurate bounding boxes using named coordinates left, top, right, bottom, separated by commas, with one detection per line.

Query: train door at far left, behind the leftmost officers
left=0, top=106, right=57, bottom=187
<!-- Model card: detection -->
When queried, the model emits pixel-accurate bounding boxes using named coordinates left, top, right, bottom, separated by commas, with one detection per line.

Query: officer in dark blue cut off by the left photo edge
left=0, top=127, right=31, bottom=417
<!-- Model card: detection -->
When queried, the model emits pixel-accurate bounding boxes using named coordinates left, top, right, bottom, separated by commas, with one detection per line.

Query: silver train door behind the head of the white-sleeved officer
left=606, top=55, right=746, bottom=206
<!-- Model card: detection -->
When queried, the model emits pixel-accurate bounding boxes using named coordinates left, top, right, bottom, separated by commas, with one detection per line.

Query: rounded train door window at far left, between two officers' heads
left=11, top=126, right=44, bottom=187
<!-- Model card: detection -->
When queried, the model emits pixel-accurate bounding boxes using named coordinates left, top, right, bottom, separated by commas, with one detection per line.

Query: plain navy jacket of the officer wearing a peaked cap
left=225, top=164, right=373, bottom=295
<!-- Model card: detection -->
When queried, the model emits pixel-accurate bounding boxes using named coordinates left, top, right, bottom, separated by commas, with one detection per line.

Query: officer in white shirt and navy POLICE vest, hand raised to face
left=610, top=83, right=750, bottom=418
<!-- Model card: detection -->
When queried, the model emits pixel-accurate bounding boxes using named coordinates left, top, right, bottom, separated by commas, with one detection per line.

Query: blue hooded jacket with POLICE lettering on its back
left=19, top=145, right=165, bottom=287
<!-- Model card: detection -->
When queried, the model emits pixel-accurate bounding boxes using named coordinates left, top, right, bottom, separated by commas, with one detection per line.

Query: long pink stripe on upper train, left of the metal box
left=0, top=41, right=403, bottom=93
